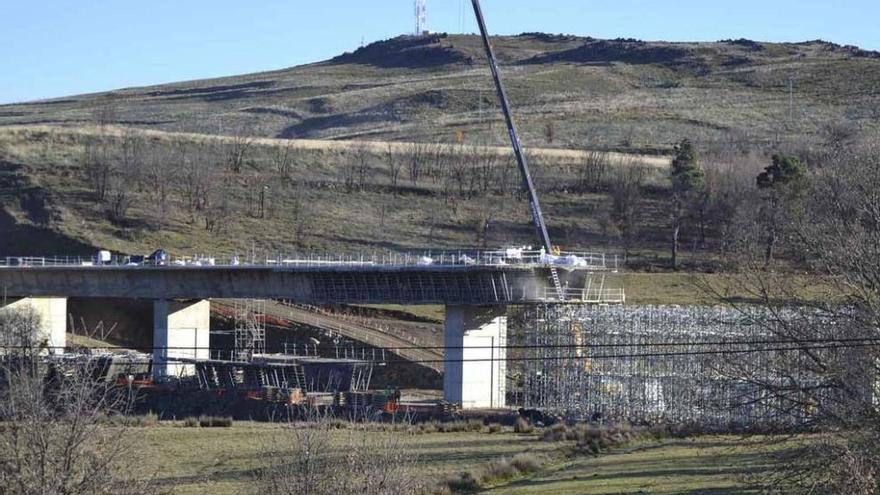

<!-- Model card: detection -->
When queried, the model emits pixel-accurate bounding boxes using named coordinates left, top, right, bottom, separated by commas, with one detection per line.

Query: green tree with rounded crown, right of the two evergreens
left=756, top=154, right=807, bottom=265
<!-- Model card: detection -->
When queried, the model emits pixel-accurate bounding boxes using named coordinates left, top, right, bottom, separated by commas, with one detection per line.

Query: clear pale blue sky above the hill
left=0, top=0, right=880, bottom=103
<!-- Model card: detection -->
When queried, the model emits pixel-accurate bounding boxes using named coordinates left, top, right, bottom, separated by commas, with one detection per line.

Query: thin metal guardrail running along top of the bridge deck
left=0, top=248, right=618, bottom=272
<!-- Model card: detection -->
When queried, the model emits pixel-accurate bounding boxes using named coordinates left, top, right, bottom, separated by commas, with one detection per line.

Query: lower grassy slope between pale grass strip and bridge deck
left=0, top=126, right=668, bottom=264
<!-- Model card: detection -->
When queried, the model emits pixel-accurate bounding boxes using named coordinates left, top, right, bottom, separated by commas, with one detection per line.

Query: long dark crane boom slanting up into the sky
left=472, top=0, right=553, bottom=253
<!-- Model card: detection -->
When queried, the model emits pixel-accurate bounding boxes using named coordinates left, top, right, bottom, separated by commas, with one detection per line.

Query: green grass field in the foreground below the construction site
left=131, top=423, right=791, bottom=495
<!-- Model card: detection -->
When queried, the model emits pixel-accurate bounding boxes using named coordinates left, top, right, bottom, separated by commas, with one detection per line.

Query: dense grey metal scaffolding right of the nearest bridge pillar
left=520, top=304, right=872, bottom=429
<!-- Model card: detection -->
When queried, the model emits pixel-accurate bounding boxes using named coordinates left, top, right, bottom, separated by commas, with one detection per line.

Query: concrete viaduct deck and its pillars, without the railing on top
left=0, top=264, right=577, bottom=407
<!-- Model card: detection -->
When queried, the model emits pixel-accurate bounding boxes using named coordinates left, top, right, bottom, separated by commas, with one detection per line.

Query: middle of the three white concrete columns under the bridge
left=153, top=299, right=211, bottom=379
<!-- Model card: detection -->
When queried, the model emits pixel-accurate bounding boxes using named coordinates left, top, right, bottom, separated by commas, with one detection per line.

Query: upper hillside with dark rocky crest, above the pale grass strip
left=0, top=33, right=880, bottom=150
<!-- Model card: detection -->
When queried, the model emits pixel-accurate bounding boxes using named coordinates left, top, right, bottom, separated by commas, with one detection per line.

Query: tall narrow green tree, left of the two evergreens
left=669, top=139, right=706, bottom=269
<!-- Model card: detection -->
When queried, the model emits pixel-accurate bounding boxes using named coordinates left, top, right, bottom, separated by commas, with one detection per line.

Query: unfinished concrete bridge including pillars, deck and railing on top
left=0, top=249, right=624, bottom=407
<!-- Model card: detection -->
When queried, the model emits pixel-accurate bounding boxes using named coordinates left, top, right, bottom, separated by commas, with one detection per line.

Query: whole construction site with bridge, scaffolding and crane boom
left=0, top=0, right=873, bottom=429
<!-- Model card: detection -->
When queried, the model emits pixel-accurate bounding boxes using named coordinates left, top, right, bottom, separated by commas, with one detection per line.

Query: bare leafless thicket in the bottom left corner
left=0, top=309, right=165, bottom=495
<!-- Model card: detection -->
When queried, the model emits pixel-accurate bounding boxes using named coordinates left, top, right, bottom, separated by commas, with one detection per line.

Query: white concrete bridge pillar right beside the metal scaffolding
left=443, top=306, right=507, bottom=408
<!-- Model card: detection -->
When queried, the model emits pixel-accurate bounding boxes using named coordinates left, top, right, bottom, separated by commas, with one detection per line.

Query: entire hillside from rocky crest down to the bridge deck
left=0, top=34, right=880, bottom=270
